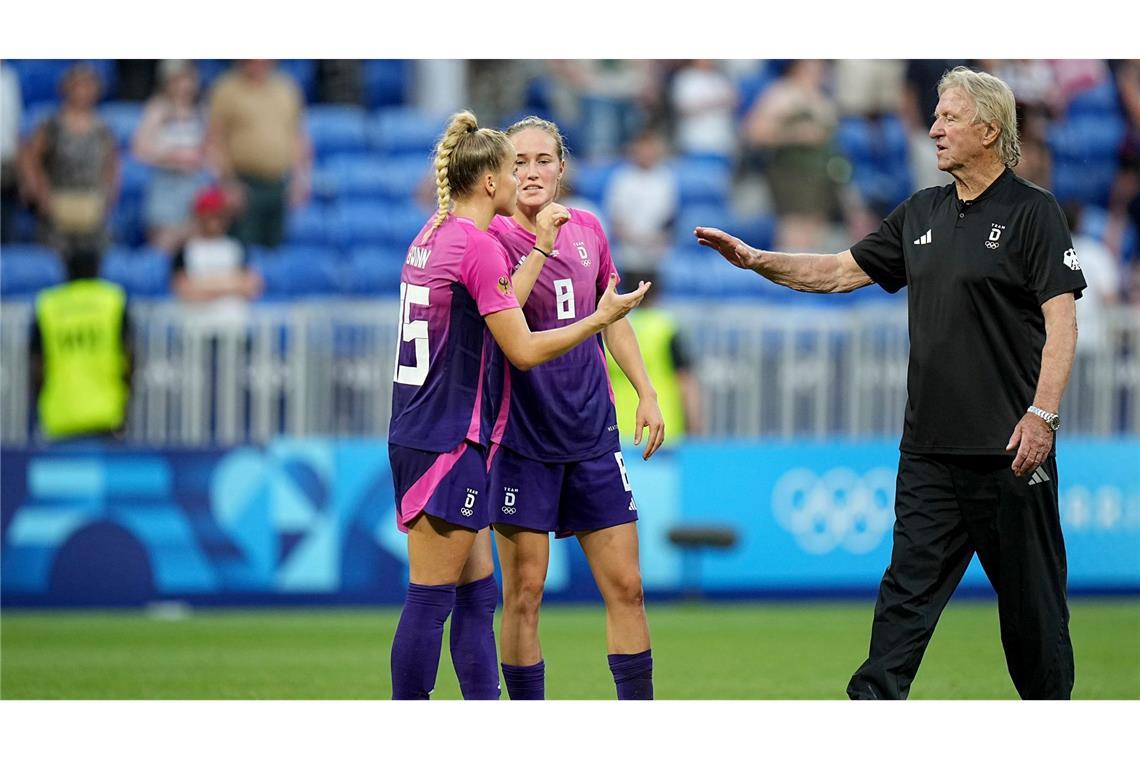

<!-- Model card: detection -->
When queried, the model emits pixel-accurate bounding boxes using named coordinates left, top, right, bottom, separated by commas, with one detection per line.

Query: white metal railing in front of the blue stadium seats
left=0, top=300, right=1140, bottom=447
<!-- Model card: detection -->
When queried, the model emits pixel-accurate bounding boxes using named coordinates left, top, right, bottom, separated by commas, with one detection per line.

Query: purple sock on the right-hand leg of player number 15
left=451, top=575, right=500, bottom=700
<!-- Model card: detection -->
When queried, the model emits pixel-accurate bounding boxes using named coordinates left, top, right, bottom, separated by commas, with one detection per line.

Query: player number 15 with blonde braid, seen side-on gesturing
left=388, top=112, right=649, bottom=698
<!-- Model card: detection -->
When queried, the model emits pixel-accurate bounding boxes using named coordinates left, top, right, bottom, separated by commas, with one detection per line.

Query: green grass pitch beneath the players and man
left=0, top=598, right=1140, bottom=700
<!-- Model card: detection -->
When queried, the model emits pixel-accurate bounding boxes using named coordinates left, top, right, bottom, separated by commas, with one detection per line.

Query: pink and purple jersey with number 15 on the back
left=388, top=216, right=519, bottom=451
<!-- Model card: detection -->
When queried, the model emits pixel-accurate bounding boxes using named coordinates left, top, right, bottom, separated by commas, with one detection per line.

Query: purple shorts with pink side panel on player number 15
left=388, top=441, right=490, bottom=533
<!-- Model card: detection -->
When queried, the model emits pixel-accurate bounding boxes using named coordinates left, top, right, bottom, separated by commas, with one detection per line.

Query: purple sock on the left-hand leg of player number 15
left=392, top=583, right=455, bottom=700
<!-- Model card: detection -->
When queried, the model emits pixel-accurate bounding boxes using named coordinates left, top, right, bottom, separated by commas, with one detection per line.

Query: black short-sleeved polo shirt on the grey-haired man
left=852, top=169, right=1085, bottom=453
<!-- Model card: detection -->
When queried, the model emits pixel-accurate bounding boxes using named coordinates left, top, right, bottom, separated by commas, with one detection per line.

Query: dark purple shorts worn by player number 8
left=487, top=446, right=637, bottom=538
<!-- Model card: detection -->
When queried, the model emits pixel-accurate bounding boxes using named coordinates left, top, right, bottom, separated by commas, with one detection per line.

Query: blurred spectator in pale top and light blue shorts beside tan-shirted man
left=131, top=60, right=206, bottom=252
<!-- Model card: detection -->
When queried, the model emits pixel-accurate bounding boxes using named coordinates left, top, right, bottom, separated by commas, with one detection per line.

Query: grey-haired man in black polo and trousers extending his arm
left=695, top=67, right=1085, bottom=700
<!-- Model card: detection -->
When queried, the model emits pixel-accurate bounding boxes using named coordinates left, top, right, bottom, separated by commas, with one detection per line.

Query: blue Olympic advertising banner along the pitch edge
left=0, top=439, right=1140, bottom=605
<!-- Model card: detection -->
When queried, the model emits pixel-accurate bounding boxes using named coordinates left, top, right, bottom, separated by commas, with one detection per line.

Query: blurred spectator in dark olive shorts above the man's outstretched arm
left=743, top=60, right=839, bottom=251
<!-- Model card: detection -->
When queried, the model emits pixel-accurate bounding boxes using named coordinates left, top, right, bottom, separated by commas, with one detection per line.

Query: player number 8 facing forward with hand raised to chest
left=490, top=116, right=665, bottom=700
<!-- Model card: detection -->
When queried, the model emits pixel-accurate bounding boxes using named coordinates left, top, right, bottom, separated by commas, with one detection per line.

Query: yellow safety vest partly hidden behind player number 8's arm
left=605, top=308, right=685, bottom=446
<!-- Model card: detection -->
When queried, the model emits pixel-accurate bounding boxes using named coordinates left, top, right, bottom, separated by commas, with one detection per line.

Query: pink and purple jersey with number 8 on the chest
left=483, top=209, right=619, bottom=463
